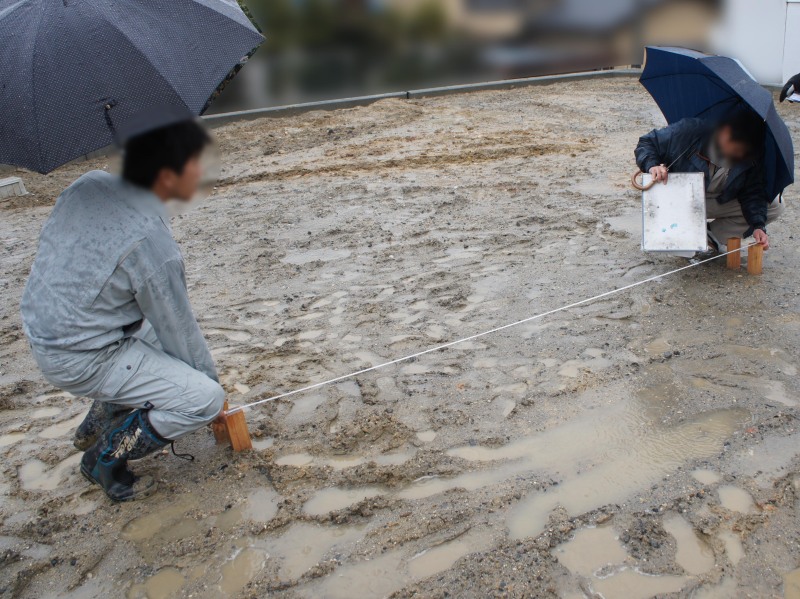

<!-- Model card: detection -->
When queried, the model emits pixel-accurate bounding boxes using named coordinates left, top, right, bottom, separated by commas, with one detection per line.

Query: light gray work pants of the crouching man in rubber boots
left=32, top=321, right=225, bottom=440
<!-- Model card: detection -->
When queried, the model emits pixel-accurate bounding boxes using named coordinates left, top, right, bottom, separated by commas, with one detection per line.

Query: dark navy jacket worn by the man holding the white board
left=636, top=119, right=772, bottom=237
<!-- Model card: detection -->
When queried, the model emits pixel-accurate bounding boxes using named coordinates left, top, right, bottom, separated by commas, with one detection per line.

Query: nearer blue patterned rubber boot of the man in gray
left=81, top=410, right=169, bottom=501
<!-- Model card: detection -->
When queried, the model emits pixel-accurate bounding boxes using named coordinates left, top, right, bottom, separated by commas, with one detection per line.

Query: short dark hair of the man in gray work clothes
left=122, top=120, right=211, bottom=189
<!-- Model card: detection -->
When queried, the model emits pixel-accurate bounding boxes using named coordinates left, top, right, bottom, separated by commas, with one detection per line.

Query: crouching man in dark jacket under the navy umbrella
left=636, top=108, right=784, bottom=250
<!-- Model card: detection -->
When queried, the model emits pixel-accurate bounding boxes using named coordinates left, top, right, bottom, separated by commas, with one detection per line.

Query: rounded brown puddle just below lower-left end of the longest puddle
left=552, top=526, right=628, bottom=576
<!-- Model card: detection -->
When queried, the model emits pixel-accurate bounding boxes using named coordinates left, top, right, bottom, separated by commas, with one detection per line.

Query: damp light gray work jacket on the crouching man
left=21, top=171, right=218, bottom=380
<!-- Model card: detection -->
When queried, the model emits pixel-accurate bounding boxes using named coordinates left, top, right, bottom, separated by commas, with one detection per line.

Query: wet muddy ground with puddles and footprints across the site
left=0, top=78, right=800, bottom=599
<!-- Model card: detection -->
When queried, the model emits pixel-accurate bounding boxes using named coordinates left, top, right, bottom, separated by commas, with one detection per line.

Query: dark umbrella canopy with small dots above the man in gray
left=0, top=0, right=263, bottom=173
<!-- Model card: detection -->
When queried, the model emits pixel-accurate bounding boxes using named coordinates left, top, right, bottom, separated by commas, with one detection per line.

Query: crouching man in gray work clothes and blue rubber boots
left=22, top=120, right=224, bottom=501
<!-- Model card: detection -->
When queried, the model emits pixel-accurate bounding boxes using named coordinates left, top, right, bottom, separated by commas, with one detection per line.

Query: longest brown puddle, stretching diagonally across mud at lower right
left=507, top=409, right=747, bottom=539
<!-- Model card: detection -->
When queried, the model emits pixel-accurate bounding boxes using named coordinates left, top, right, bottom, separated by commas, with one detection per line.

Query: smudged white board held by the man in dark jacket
left=642, top=173, right=708, bottom=252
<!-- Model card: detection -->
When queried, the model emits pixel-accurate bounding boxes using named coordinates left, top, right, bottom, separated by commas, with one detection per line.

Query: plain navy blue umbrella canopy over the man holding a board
left=639, top=47, right=794, bottom=198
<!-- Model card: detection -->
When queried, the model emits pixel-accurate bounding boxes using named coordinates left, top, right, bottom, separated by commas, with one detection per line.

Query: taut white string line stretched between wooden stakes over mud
left=227, top=242, right=758, bottom=414
